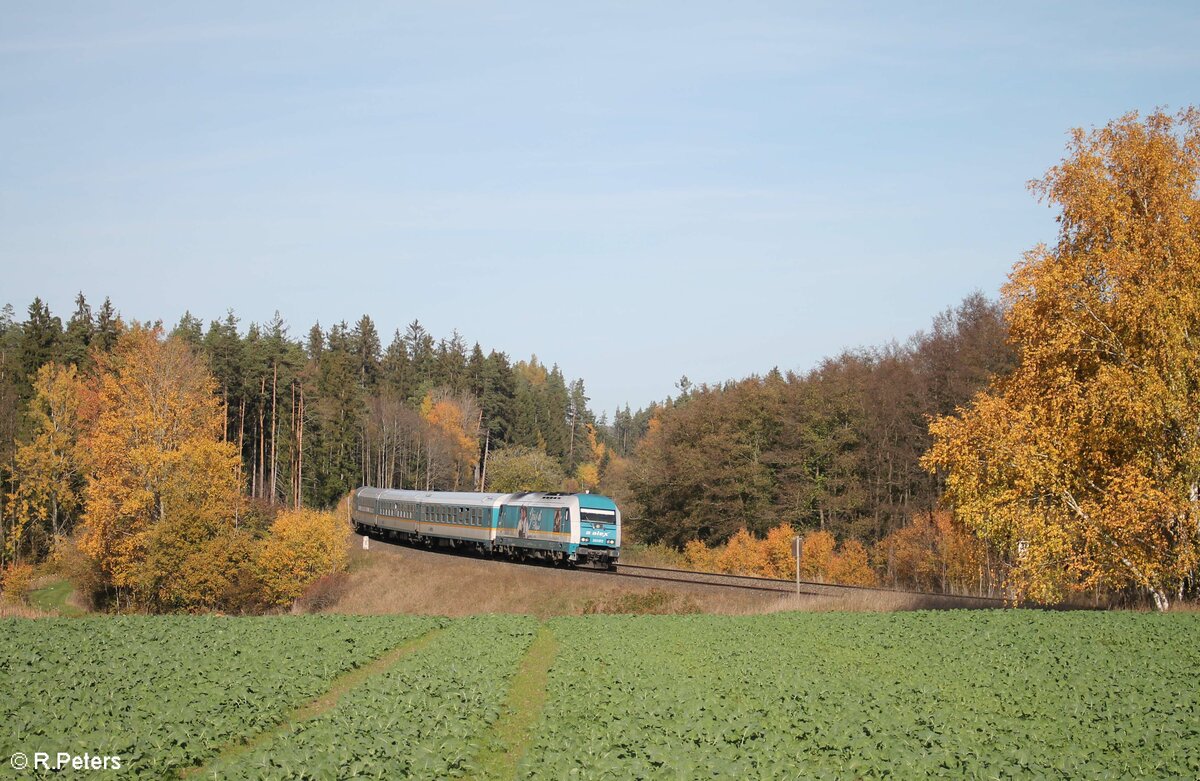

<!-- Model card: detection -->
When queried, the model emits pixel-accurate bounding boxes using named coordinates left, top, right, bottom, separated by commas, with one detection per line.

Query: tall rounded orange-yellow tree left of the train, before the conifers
left=79, top=324, right=245, bottom=609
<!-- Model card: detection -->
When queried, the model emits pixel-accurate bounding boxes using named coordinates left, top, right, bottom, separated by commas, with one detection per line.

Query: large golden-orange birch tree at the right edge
left=925, top=109, right=1200, bottom=609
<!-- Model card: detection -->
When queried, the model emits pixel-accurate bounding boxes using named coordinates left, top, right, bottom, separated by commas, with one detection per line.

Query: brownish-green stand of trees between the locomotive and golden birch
left=618, top=294, right=1015, bottom=547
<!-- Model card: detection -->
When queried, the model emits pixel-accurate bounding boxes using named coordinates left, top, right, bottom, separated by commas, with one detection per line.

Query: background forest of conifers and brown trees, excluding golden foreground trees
left=0, top=286, right=1012, bottom=599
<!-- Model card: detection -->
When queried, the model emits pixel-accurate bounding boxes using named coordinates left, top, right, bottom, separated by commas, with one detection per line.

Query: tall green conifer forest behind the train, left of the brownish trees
left=0, top=294, right=614, bottom=565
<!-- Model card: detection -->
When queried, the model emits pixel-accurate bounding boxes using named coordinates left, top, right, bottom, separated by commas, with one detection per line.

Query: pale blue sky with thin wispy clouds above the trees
left=0, top=0, right=1200, bottom=417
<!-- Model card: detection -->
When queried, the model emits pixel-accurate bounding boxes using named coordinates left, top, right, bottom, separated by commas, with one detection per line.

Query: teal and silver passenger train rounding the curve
left=350, top=486, right=620, bottom=569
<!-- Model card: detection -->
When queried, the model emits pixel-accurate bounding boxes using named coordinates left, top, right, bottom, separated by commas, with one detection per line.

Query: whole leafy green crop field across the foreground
left=0, top=611, right=1200, bottom=779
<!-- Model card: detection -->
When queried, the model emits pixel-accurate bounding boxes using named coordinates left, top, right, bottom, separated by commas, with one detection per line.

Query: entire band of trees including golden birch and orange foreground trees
left=0, top=110, right=1200, bottom=609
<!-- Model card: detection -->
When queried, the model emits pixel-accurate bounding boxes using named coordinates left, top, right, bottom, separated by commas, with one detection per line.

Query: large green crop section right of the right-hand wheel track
left=521, top=611, right=1200, bottom=779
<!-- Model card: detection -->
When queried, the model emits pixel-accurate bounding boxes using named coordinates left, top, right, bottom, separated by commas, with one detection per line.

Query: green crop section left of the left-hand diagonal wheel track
left=0, top=617, right=445, bottom=779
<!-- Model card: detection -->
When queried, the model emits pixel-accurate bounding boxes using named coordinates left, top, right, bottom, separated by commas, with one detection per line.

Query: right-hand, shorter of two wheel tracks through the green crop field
left=472, top=624, right=558, bottom=781
